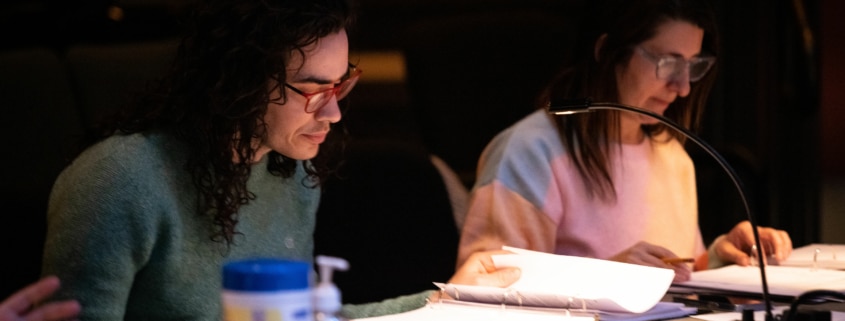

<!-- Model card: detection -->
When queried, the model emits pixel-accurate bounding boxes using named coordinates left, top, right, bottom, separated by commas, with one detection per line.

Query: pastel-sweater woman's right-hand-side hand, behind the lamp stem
left=713, top=221, right=792, bottom=266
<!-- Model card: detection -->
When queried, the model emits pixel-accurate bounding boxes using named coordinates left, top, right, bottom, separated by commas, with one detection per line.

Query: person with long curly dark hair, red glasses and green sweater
left=42, top=0, right=519, bottom=320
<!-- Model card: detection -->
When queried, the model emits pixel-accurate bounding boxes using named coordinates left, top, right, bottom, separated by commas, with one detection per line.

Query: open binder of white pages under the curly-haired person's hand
left=352, top=246, right=696, bottom=321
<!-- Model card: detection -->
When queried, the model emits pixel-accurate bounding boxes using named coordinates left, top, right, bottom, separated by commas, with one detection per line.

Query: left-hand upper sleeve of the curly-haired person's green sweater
left=42, top=139, right=163, bottom=320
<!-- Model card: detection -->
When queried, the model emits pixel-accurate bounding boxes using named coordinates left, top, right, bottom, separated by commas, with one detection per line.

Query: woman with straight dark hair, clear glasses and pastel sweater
left=458, top=0, right=792, bottom=282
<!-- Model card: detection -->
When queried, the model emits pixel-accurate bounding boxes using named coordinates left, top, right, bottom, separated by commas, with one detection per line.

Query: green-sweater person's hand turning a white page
left=429, top=250, right=521, bottom=300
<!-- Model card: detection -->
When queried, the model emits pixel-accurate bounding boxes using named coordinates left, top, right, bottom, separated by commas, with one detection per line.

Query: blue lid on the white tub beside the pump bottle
left=223, top=258, right=311, bottom=291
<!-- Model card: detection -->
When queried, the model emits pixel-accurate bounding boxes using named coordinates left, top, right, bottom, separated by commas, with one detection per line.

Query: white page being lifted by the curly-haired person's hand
left=437, top=247, right=675, bottom=313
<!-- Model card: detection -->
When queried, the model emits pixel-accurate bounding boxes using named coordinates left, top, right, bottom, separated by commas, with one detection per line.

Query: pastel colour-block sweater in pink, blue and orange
left=458, top=110, right=705, bottom=266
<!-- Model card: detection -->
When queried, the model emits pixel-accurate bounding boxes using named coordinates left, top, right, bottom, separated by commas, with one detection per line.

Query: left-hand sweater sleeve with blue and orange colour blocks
left=457, top=113, right=562, bottom=266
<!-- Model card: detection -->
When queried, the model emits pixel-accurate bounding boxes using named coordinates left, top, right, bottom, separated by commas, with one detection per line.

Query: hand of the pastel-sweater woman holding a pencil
left=610, top=242, right=692, bottom=282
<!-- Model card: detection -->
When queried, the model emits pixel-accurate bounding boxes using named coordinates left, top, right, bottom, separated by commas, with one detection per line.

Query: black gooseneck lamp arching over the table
left=547, top=98, right=774, bottom=321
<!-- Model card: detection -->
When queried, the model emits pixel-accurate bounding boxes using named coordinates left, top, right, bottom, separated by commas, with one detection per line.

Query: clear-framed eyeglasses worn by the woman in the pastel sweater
left=637, top=47, right=716, bottom=82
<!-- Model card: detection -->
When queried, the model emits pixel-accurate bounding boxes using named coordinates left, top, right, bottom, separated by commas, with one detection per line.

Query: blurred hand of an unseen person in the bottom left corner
left=0, top=276, right=82, bottom=321
